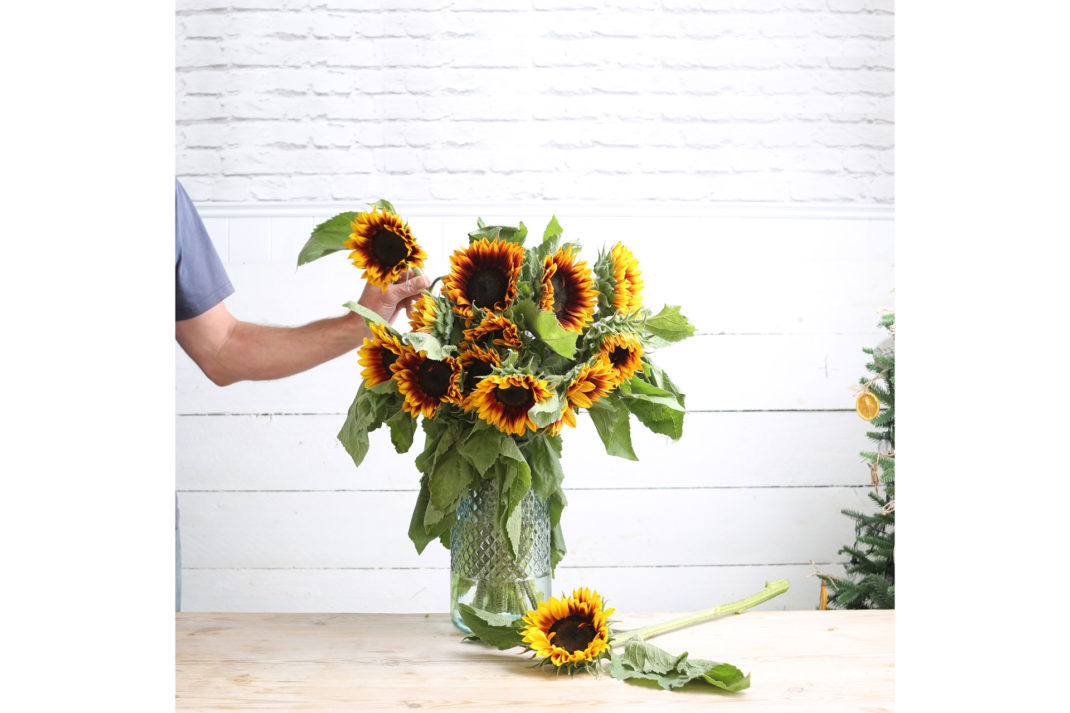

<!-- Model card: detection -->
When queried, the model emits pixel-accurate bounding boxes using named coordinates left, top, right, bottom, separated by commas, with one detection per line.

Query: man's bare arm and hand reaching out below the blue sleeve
left=174, top=271, right=431, bottom=386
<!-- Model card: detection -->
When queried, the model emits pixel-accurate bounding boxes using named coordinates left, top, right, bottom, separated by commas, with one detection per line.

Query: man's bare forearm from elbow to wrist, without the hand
left=209, top=313, right=370, bottom=385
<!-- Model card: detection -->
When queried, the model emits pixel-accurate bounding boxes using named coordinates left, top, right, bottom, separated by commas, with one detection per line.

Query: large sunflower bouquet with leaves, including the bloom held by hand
left=297, top=200, right=694, bottom=620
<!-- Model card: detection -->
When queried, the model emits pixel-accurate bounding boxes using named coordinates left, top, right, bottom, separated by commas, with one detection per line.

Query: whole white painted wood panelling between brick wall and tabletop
left=175, top=203, right=893, bottom=611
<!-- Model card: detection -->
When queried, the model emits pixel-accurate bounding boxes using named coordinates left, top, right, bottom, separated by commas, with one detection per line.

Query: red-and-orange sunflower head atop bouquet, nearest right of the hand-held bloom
left=442, top=238, right=524, bottom=317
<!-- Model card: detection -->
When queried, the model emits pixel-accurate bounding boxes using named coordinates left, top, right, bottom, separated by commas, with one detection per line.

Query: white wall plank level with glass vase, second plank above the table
left=179, top=487, right=866, bottom=567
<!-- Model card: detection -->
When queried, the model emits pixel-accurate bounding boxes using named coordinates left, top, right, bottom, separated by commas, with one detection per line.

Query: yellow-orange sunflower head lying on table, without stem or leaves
left=522, top=587, right=613, bottom=666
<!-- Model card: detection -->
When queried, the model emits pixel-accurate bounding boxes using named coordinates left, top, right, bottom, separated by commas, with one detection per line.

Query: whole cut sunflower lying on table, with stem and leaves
left=461, top=579, right=789, bottom=692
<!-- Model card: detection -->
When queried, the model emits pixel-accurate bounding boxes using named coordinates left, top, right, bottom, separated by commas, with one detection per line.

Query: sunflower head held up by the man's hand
left=343, top=208, right=427, bottom=292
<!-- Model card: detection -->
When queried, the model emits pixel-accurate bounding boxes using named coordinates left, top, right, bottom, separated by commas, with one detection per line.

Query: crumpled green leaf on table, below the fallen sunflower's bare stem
left=610, top=638, right=750, bottom=692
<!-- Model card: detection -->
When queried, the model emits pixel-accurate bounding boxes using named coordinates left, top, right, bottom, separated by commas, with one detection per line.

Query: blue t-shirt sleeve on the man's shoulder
left=174, top=179, right=234, bottom=321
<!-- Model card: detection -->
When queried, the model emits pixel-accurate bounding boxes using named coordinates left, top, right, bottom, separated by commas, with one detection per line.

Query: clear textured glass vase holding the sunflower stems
left=449, top=477, right=550, bottom=634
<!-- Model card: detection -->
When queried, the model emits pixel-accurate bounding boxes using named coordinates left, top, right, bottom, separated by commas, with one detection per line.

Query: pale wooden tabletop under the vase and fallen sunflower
left=175, top=610, right=895, bottom=713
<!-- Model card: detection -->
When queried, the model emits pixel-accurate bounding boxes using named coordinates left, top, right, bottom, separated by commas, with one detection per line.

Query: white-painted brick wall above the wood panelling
left=175, top=0, right=895, bottom=203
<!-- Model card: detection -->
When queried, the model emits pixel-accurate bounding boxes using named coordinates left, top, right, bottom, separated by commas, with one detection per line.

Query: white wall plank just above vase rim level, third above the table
left=177, top=411, right=869, bottom=490
